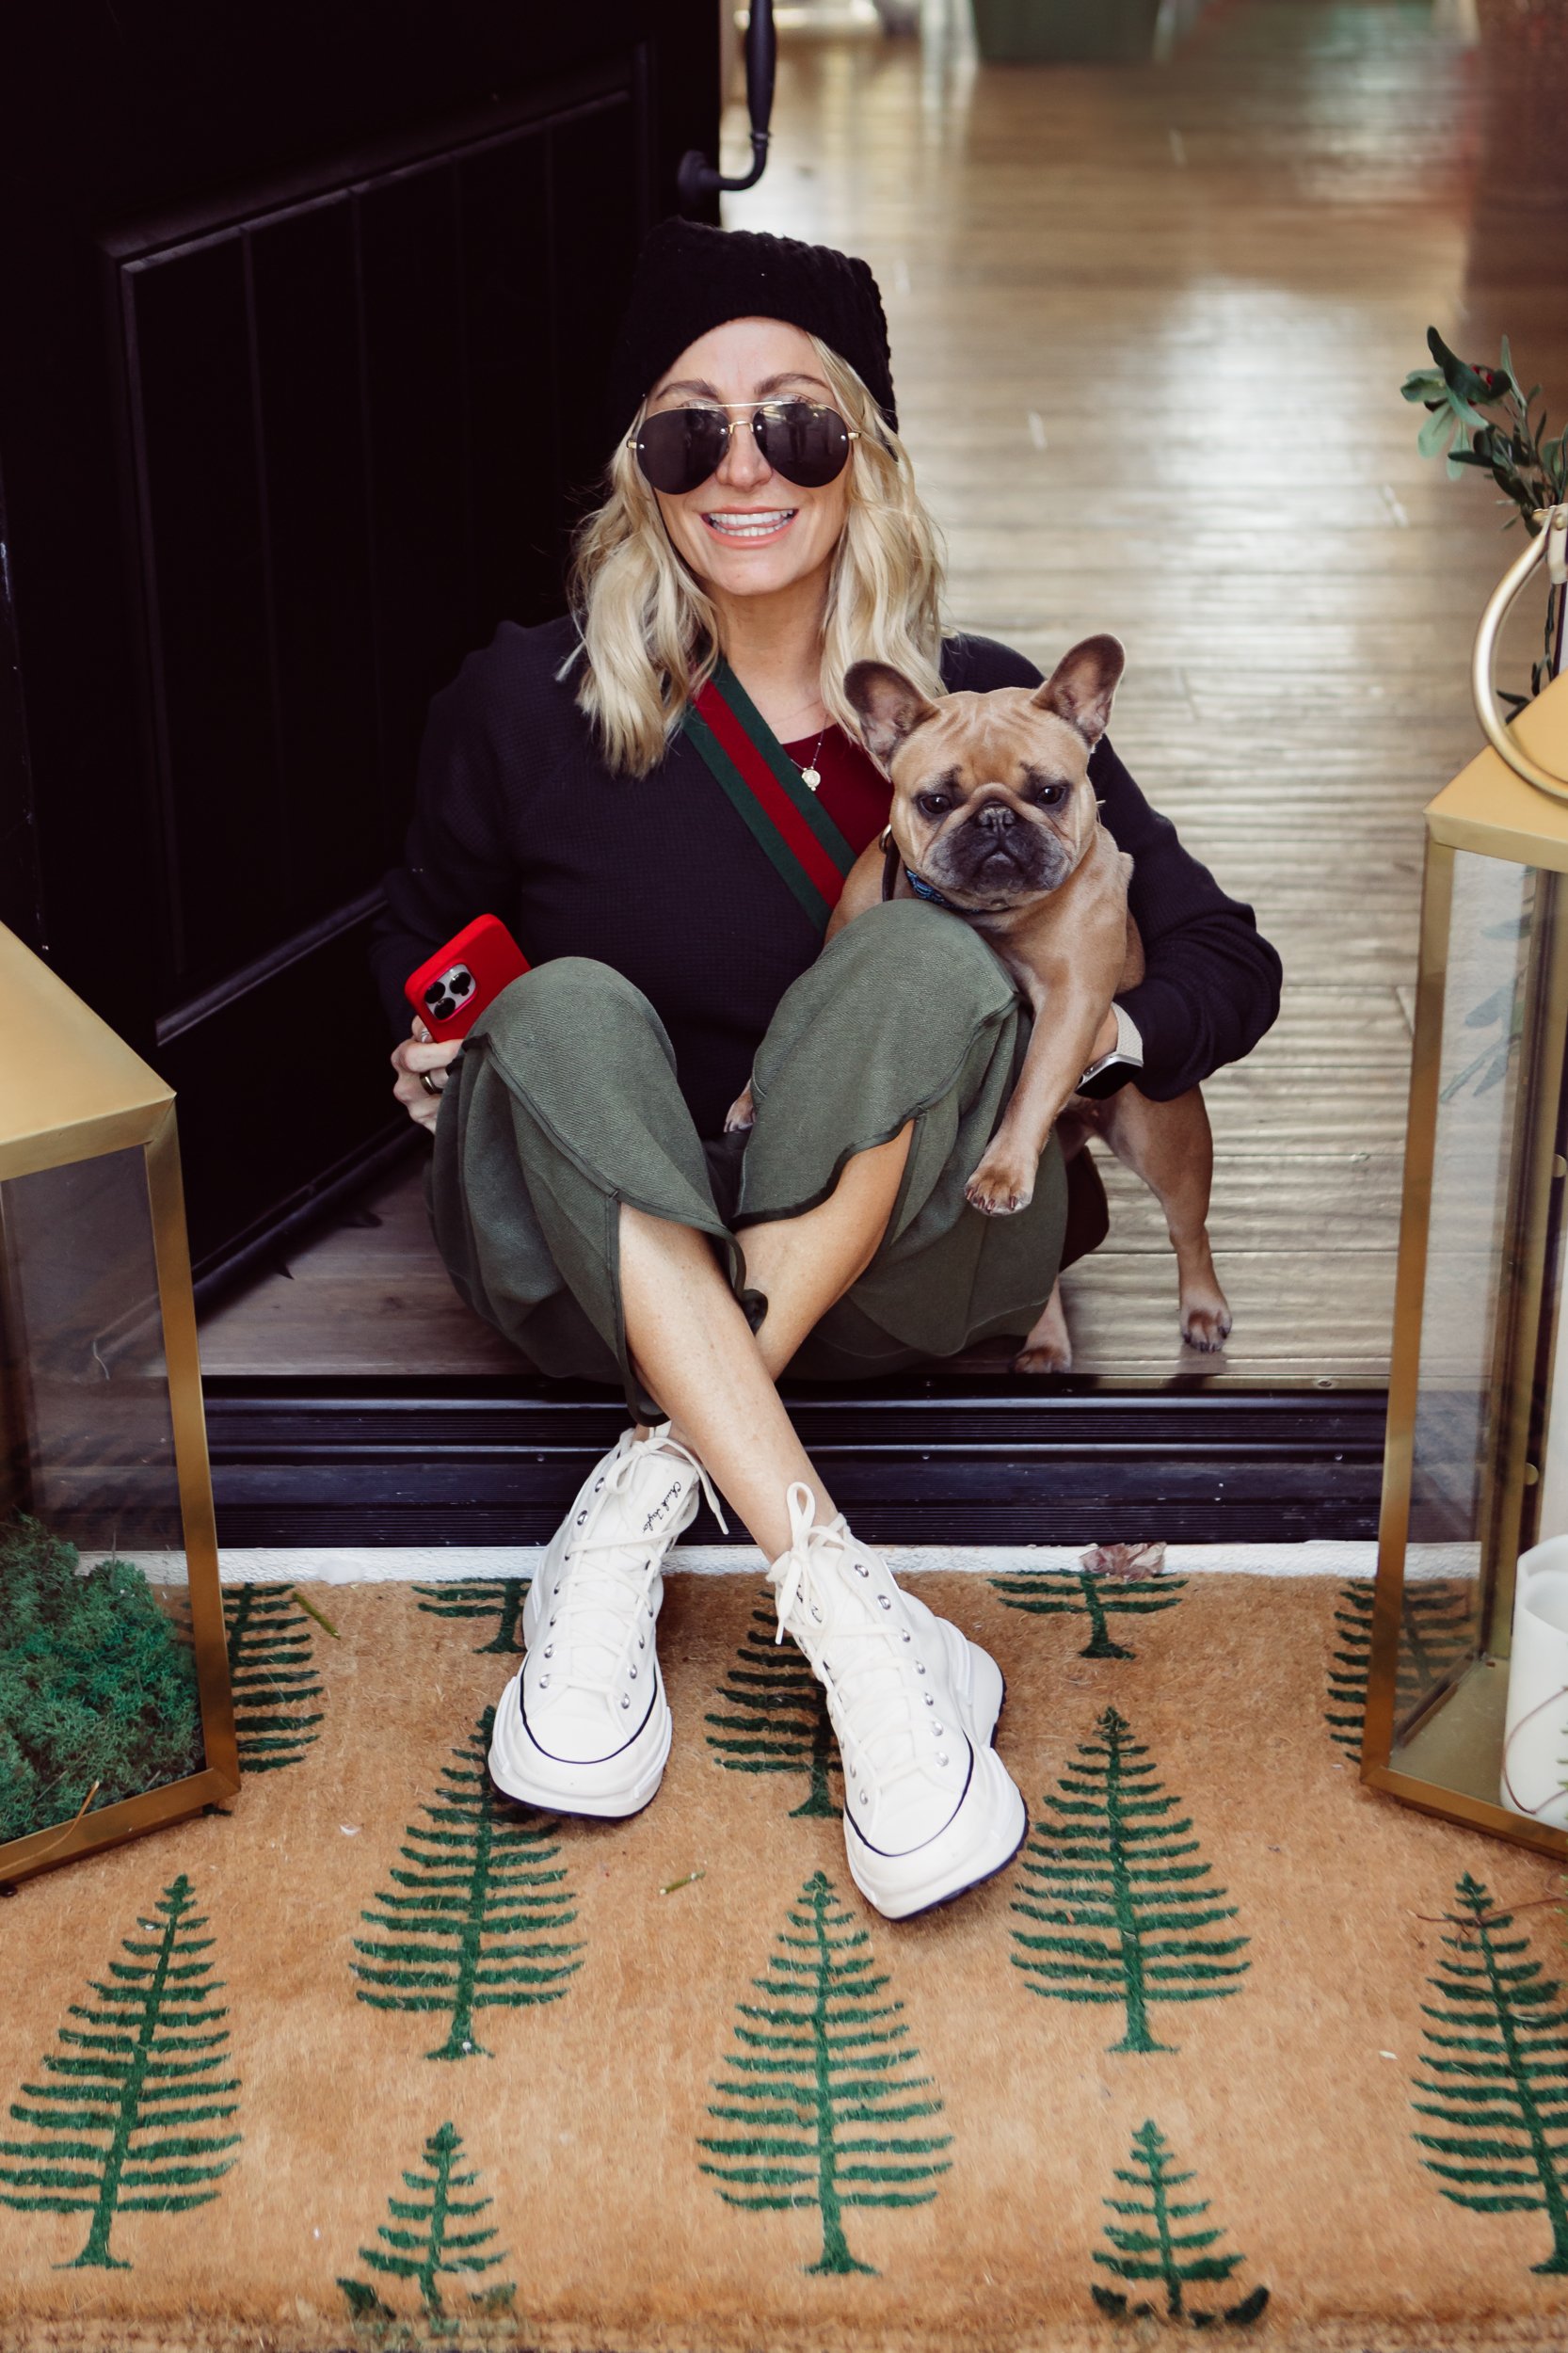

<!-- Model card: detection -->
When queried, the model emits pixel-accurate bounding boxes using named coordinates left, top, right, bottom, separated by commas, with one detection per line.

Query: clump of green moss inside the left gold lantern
left=0, top=1518, right=202, bottom=1845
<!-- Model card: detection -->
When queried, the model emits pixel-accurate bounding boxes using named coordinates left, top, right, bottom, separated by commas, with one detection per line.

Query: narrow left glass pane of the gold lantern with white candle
left=1394, top=852, right=1540, bottom=1760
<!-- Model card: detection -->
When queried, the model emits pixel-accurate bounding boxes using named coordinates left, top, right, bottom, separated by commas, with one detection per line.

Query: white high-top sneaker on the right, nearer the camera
left=767, top=1485, right=1029, bottom=1920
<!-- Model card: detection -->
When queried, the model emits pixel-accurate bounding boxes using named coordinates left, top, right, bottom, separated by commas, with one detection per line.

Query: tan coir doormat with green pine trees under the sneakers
left=0, top=1575, right=1568, bottom=2353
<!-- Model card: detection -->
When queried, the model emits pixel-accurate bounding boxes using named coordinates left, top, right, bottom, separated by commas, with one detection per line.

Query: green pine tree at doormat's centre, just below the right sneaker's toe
left=696, top=1871, right=952, bottom=2273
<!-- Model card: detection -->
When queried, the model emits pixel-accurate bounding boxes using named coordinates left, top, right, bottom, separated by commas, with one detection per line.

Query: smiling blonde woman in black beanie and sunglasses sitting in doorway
left=376, top=221, right=1278, bottom=1918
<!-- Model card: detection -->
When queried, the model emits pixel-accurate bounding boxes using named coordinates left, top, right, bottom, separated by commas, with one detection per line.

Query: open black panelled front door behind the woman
left=0, top=0, right=718, bottom=1271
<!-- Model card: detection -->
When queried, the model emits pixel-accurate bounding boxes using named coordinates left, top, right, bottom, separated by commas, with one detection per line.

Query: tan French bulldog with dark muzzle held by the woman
left=729, top=635, right=1231, bottom=1372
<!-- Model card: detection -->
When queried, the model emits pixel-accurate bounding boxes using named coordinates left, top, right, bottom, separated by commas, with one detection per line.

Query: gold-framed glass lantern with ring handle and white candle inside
left=1361, top=574, right=1568, bottom=1857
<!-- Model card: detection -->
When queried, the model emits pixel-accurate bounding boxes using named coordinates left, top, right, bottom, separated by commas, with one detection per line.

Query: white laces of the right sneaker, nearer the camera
left=770, top=1482, right=947, bottom=1791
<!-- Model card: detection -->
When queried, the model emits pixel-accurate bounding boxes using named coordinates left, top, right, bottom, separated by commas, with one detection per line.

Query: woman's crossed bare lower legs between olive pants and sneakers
left=621, top=1125, right=911, bottom=1561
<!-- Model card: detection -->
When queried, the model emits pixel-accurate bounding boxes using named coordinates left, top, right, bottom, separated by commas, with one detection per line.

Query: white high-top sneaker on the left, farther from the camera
left=489, top=1421, right=725, bottom=1817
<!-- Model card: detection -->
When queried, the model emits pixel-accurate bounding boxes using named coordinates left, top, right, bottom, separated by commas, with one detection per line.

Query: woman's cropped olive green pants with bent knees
left=428, top=899, right=1066, bottom=1421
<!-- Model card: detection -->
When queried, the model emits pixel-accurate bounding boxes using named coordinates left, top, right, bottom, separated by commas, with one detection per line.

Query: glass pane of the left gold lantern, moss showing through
left=0, top=1148, right=205, bottom=1845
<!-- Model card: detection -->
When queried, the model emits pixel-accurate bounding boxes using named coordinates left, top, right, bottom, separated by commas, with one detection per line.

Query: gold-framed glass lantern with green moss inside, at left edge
left=0, top=927, right=240, bottom=1885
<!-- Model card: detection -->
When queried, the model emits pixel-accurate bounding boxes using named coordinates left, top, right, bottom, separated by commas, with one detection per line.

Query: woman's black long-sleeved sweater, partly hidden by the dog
left=372, top=619, right=1281, bottom=1137
